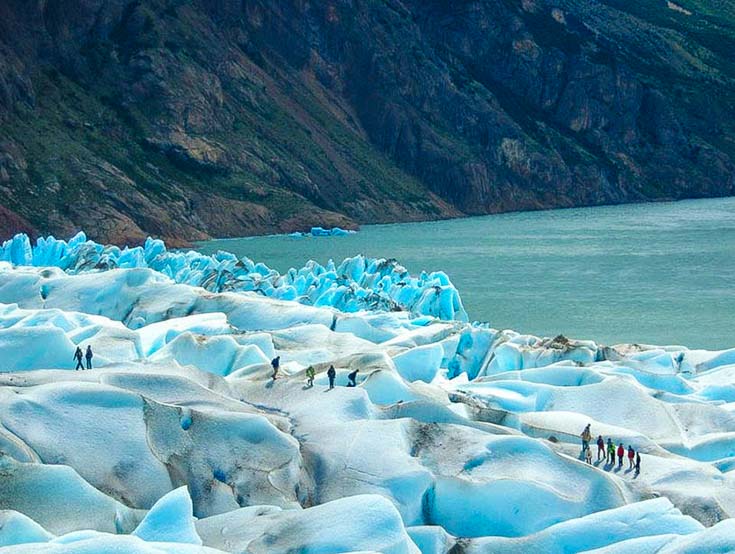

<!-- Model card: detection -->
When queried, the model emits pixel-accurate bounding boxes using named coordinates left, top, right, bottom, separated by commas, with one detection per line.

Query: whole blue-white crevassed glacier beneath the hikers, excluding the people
left=0, top=234, right=735, bottom=554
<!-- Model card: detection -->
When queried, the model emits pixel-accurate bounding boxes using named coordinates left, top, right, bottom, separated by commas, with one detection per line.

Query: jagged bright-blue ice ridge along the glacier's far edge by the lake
left=0, top=232, right=467, bottom=321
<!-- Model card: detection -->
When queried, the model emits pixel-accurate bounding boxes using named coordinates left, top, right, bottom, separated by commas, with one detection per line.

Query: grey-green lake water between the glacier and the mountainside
left=199, top=198, right=735, bottom=348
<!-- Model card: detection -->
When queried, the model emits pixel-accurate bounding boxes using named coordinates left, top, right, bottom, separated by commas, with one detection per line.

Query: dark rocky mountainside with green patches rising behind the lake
left=0, top=0, right=735, bottom=242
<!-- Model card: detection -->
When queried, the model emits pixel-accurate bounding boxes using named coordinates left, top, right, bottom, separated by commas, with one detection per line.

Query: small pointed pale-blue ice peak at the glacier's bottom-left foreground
left=133, top=487, right=202, bottom=545
